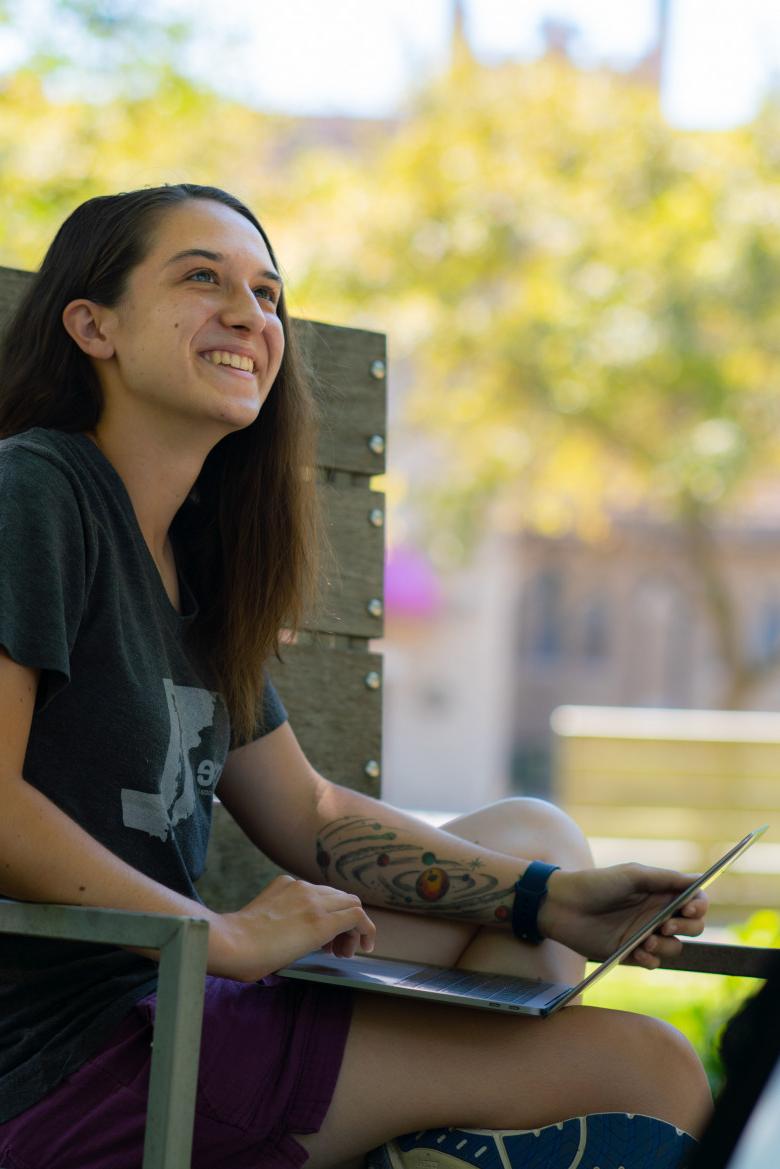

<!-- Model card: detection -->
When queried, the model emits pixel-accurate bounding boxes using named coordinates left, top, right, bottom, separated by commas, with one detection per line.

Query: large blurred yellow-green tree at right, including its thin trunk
left=291, top=55, right=780, bottom=706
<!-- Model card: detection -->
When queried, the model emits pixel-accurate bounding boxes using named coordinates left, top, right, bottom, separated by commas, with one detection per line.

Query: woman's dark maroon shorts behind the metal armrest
left=0, top=977, right=352, bottom=1169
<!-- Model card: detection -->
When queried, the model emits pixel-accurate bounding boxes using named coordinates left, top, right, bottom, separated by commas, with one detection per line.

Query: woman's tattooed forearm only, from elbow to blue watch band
left=316, top=784, right=527, bottom=925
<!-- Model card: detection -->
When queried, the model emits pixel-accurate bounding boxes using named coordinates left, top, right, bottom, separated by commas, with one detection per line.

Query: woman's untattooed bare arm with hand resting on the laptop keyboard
left=0, top=649, right=373, bottom=981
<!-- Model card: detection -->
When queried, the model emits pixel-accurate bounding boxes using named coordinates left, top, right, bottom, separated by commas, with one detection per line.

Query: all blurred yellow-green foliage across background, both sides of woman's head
left=0, top=36, right=780, bottom=705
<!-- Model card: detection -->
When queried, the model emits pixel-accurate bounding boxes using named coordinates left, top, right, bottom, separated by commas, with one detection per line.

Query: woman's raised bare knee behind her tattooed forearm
left=472, top=796, right=593, bottom=869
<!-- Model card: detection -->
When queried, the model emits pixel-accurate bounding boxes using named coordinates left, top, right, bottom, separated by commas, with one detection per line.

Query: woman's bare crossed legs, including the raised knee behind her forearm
left=298, top=800, right=711, bottom=1169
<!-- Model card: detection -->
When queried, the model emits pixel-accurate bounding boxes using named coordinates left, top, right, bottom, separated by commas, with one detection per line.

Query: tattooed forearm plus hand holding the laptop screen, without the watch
left=308, top=784, right=706, bottom=969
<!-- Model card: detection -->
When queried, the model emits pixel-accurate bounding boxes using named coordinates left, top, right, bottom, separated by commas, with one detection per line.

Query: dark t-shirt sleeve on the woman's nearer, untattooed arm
left=0, top=448, right=87, bottom=710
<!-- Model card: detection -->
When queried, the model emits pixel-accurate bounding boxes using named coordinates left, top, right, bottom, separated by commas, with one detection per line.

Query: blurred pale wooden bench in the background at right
left=551, top=706, right=780, bottom=921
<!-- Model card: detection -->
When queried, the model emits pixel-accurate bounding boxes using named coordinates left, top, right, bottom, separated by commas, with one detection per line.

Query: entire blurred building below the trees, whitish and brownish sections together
left=382, top=514, right=780, bottom=812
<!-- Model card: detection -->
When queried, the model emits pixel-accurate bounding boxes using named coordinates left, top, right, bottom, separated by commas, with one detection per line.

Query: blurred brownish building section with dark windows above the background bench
left=511, top=514, right=780, bottom=789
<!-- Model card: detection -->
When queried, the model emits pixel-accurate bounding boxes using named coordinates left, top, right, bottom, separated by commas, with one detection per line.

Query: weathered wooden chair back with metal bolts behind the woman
left=199, top=320, right=386, bottom=911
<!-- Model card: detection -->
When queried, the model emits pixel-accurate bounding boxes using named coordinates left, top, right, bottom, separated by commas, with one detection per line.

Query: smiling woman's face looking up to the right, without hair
left=96, top=199, right=284, bottom=438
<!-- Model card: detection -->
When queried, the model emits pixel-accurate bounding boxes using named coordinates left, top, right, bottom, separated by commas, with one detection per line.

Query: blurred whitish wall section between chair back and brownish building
left=382, top=534, right=517, bottom=812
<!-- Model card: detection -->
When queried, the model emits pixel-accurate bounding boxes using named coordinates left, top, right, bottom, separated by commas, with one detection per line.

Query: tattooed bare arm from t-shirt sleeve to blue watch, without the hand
left=216, top=724, right=531, bottom=925
